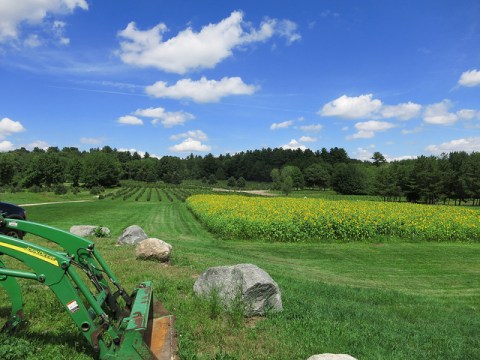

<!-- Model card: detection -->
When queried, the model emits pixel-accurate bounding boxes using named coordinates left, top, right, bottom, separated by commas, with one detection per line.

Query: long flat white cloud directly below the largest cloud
left=145, top=77, right=258, bottom=103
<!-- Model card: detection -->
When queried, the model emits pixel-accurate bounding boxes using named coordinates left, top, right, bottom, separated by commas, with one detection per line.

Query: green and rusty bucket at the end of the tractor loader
left=116, top=281, right=177, bottom=360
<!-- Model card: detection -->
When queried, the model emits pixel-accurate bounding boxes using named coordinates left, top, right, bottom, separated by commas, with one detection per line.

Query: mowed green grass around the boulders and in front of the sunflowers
left=0, top=199, right=480, bottom=360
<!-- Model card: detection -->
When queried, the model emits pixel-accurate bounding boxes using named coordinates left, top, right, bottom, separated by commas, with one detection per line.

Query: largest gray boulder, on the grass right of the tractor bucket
left=193, top=264, right=283, bottom=316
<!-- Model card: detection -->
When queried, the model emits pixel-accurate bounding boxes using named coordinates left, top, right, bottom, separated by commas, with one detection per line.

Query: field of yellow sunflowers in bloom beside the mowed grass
left=187, top=195, right=480, bottom=242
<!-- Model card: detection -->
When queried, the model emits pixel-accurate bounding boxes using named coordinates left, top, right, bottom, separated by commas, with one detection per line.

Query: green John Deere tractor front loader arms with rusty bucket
left=0, top=216, right=176, bottom=360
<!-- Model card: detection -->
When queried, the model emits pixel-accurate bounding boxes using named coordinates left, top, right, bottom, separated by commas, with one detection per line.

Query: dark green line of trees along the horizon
left=0, top=146, right=480, bottom=205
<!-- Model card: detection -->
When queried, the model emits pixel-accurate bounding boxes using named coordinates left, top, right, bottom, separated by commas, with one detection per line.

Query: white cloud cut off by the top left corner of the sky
left=0, top=0, right=88, bottom=42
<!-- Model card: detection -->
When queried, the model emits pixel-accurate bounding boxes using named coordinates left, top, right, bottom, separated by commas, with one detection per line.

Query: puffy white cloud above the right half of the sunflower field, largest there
left=318, top=94, right=382, bottom=119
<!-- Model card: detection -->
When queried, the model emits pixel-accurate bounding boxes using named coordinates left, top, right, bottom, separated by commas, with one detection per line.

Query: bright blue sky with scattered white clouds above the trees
left=0, top=0, right=480, bottom=160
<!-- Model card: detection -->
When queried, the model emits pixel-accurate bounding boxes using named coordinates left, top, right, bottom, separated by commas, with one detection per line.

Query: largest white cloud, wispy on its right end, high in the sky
left=118, top=11, right=300, bottom=74
